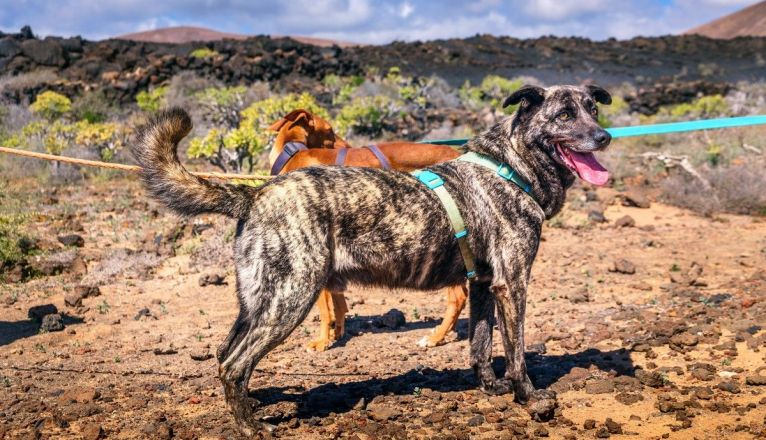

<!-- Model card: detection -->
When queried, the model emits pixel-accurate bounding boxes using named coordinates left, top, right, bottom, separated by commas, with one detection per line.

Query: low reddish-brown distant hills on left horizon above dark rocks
left=114, top=26, right=354, bottom=47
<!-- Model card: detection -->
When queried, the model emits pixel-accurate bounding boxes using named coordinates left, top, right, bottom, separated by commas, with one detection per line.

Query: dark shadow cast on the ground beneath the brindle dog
left=251, top=348, right=635, bottom=423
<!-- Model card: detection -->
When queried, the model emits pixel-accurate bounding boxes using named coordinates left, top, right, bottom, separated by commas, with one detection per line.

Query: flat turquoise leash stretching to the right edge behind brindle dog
left=419, top=115, right=766, bottom=146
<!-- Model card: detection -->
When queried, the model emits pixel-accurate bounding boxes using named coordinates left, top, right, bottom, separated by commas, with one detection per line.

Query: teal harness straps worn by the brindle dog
left=412, top=152, right=530, bottom=279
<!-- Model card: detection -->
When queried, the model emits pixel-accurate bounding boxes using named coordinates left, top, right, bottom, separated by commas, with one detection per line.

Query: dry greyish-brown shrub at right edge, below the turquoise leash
left=661, top=160, right=766, bottom=216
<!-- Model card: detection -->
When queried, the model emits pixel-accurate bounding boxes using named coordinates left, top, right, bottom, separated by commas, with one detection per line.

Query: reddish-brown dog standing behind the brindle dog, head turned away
left=269, top=109, right=468, bottom=351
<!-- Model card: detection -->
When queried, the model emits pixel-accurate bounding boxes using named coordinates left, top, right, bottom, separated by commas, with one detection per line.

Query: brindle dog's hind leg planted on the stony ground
left=218, top=272, right=324, bottom=436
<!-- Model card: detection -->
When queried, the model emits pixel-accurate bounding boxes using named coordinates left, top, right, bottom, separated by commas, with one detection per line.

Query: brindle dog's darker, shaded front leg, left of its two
left=468, top=281, right=510, bottom=394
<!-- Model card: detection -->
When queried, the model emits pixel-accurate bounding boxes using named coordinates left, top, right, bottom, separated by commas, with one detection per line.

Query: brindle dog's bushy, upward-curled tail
left=131, top=108, right=258, bottom=219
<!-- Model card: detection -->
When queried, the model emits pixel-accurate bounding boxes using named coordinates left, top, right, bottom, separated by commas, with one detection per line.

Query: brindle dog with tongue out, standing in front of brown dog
left=133, top=86, right=611, bottom=434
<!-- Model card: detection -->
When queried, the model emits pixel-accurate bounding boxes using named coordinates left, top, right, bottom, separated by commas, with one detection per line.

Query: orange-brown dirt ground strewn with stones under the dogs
left=0, top=179, right=766, bottom=439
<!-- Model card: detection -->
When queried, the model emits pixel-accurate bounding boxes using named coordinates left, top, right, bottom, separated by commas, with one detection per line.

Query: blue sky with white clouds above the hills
left=0, top=0, right=758, bottom=44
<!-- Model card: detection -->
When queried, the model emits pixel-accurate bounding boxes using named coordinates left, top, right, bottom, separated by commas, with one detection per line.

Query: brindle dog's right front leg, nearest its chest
left=492, top=277, right=535, bottom=403
